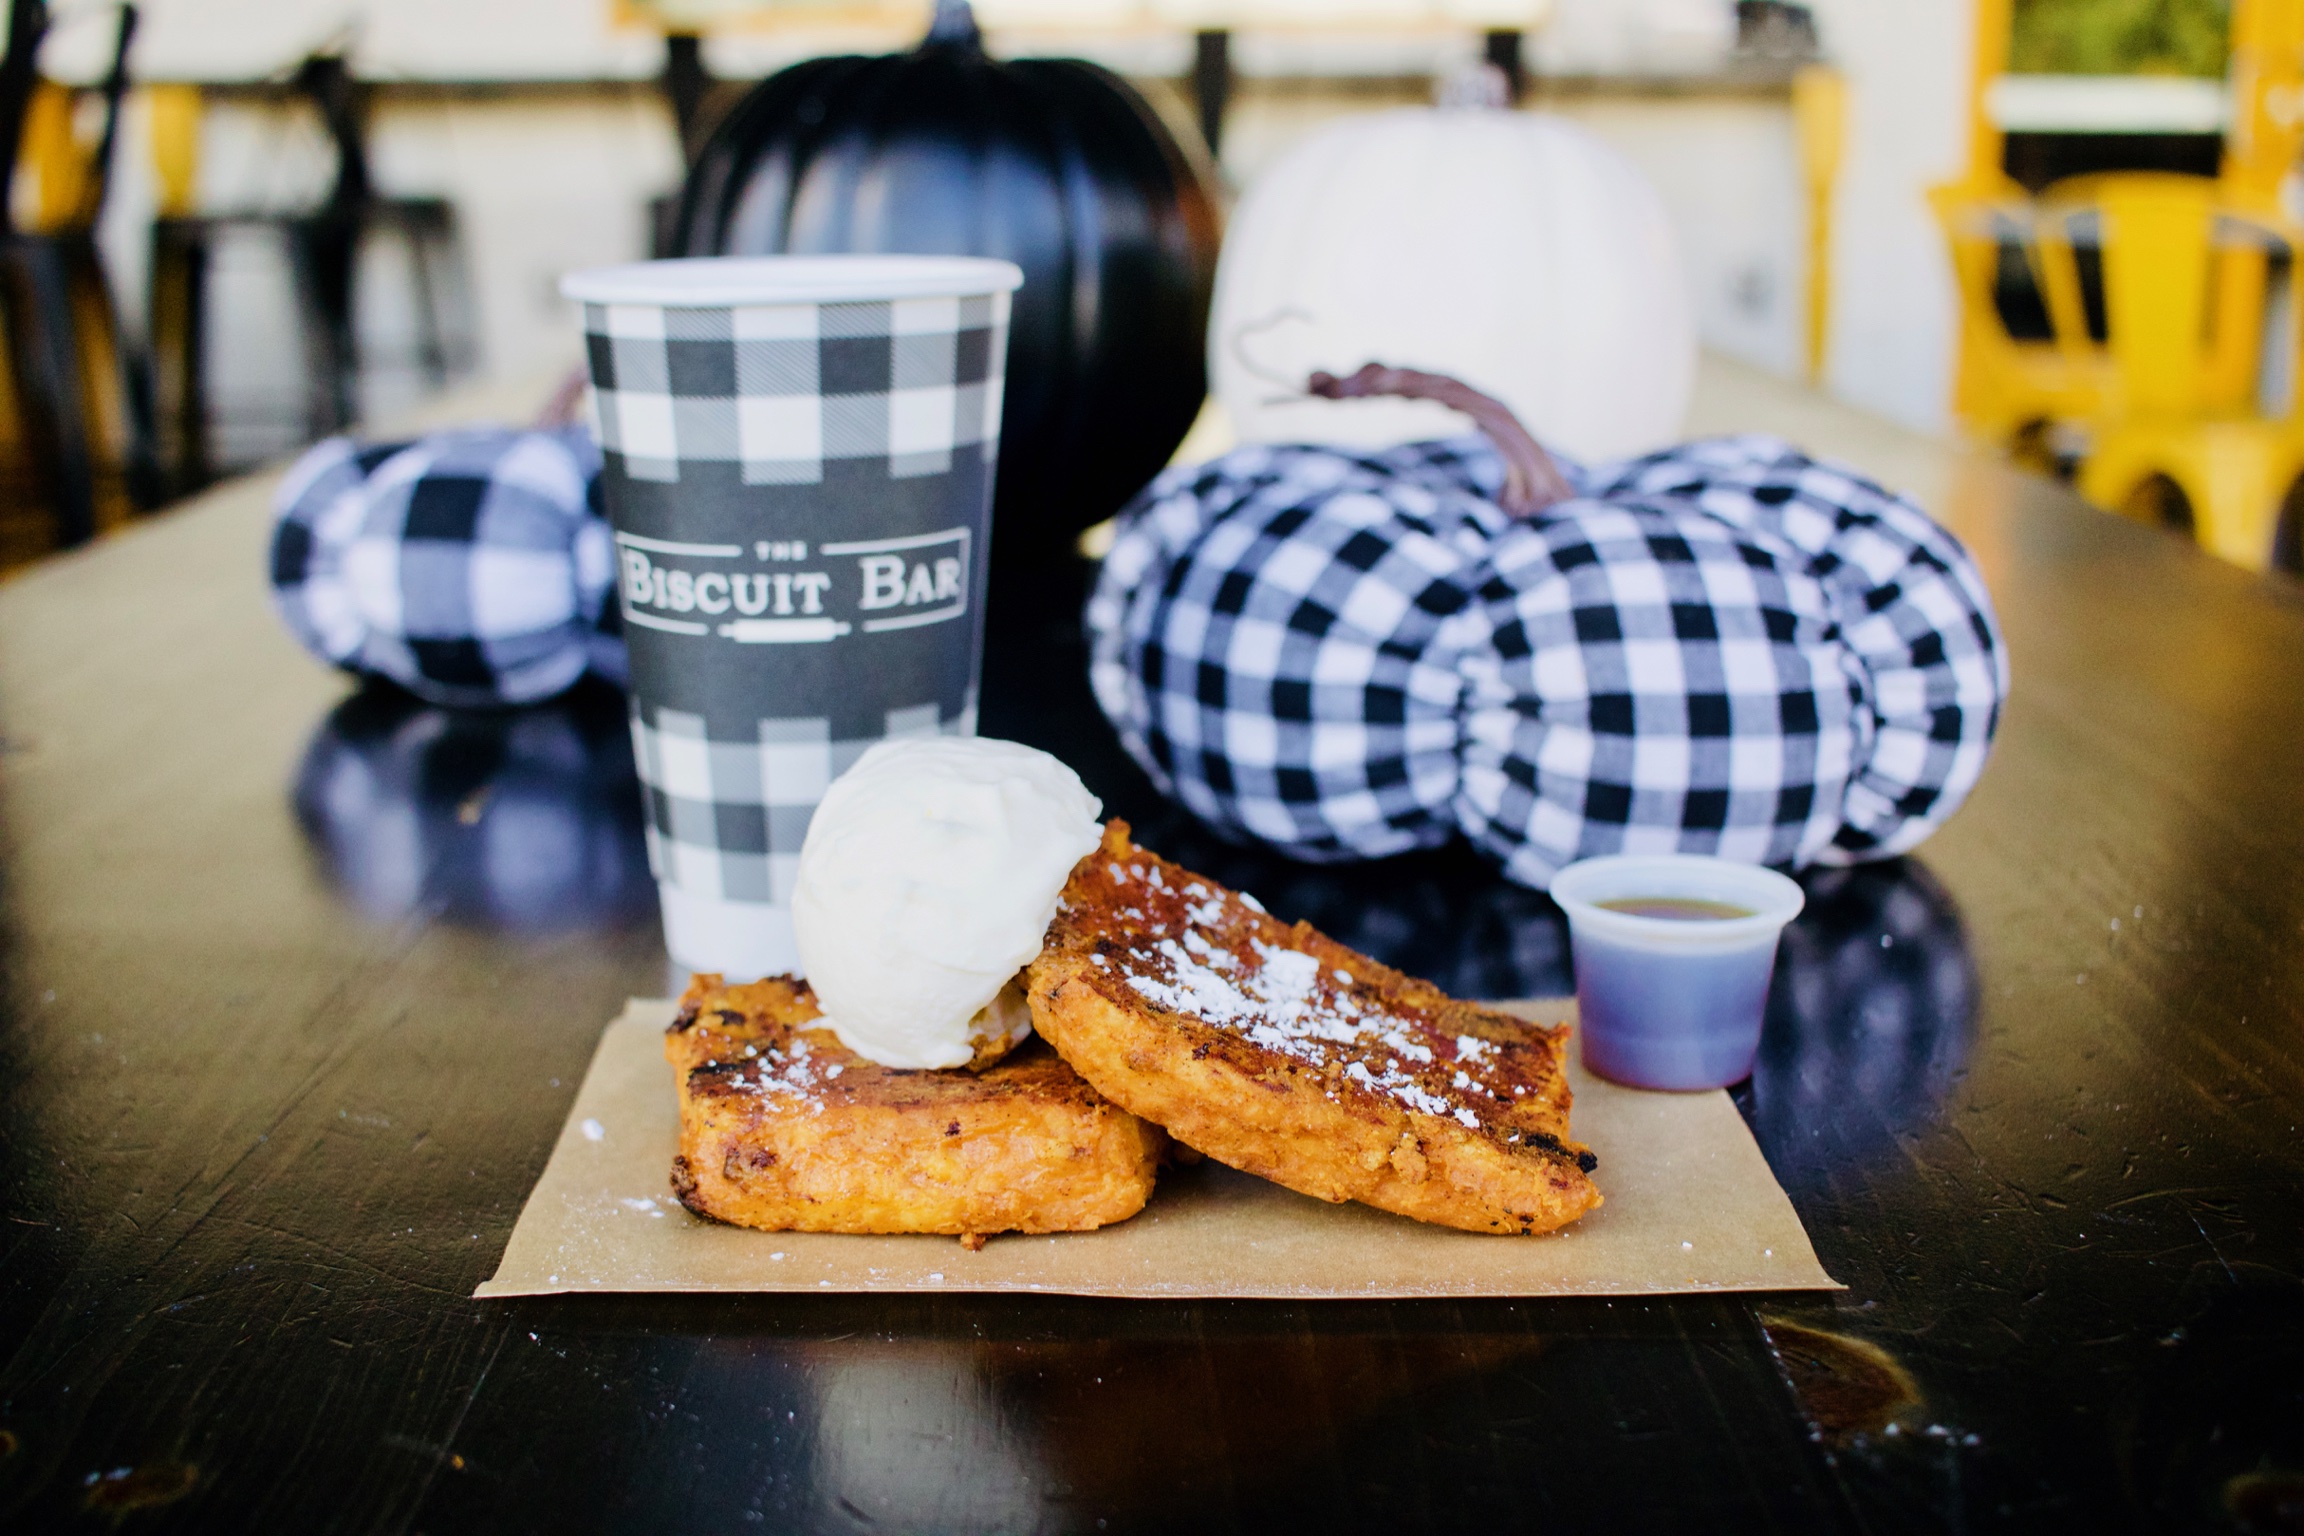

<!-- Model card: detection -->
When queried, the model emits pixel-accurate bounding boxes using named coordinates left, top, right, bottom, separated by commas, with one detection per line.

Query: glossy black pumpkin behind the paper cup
left=673, top=0, right=1219, bottom=571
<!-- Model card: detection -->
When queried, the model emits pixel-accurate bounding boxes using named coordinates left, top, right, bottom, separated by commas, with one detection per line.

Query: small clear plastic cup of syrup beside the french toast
left=1553, top=854, right=1806, bottom=1089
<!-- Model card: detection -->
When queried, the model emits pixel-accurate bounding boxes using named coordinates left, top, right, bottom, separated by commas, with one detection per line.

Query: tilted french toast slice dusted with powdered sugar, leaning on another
left=1028, top=820, right=1601, bottom=1232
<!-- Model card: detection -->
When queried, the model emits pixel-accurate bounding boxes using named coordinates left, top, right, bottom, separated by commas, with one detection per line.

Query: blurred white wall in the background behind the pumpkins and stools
left=72, top=0, right=1972, bottom=451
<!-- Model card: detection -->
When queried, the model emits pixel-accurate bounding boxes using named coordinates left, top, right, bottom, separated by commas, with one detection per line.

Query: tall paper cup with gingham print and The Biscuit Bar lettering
left=560, top=256, right=1023, bottom=976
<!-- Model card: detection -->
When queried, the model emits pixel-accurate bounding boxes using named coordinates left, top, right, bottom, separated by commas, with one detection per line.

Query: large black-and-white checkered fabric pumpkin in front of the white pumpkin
left=1087, top=438, right=2007, bottom=887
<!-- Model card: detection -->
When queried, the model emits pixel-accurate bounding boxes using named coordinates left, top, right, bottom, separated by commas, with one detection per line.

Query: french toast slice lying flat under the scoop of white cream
left=664, top=976, right=1168, bottom=1244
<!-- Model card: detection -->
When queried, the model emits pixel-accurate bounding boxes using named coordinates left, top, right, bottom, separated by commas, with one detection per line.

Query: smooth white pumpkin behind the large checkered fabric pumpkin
left=1207, top=106, right=1696, bottom=461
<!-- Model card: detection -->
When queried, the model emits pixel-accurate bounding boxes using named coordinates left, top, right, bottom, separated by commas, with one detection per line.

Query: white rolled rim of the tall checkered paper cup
left=560, top=253, right=1023, bottom=309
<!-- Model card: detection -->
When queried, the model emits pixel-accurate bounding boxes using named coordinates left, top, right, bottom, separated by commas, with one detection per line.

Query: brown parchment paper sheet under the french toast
left=477, top=999, right=1841, bottom=1299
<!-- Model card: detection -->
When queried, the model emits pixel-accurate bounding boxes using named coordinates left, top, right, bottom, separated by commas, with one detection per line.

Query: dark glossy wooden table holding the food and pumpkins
left=0, top=356, right=2304, bottom=1531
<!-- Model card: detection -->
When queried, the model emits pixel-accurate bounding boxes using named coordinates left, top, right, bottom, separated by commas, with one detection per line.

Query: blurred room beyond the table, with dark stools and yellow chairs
left=0, top=0, right=2304, bottom=580
